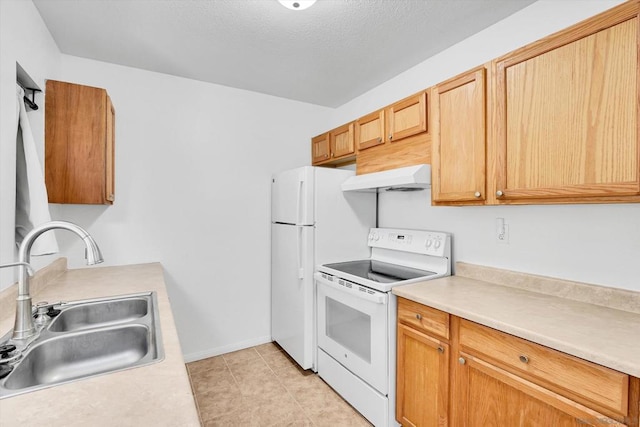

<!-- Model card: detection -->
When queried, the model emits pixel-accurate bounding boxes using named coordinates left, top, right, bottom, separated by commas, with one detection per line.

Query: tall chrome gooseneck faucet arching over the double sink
left=12, top=221, right=103, bottom=340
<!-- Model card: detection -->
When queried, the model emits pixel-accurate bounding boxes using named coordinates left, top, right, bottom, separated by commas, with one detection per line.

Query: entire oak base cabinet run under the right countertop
left=396, top=298, right=640, bottom=427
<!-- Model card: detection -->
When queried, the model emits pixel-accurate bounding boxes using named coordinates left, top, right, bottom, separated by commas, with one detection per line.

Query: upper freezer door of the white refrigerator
left=271, top=166, right=314, bottom=225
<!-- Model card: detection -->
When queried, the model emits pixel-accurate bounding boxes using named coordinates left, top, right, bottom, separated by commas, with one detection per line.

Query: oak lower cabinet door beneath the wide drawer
left=452, top=353, right=626, bottom=427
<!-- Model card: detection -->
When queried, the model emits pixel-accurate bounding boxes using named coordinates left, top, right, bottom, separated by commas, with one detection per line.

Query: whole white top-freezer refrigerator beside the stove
left=271, top=166, right=377, bottom=370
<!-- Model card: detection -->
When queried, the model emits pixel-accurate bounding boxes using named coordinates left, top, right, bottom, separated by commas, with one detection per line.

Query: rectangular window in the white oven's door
left=325, top=297, right=371, bottom=363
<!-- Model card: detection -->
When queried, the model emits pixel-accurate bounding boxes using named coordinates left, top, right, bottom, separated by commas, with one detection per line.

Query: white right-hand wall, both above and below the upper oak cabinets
left=332, top=0, right=640, bottom=291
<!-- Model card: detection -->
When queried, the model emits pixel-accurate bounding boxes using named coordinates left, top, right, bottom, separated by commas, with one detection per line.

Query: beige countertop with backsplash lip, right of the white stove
left=393, top=263, right=640, bottom=377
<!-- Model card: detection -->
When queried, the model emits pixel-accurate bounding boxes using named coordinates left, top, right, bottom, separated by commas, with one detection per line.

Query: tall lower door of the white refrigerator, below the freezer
left=271, top=224, right=315, bottom=369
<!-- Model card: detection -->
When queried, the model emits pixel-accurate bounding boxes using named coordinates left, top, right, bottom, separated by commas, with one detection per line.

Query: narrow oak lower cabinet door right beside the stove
left=396, top=325, right=449, bottom=426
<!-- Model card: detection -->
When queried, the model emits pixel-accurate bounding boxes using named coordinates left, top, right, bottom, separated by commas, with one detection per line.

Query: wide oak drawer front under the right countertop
left=460, top=320, right=629, bottom=415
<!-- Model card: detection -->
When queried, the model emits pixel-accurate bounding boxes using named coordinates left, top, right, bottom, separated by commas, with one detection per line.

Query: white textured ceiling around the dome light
left=34, top=0, right=534, bottom=107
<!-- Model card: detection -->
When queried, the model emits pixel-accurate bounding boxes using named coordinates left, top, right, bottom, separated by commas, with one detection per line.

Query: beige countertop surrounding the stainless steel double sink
left=0, top=259, right=200, bottom=427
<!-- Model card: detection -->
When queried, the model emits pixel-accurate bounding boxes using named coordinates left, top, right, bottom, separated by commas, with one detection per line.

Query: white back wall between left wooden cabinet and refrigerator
left=47, top=55, right=329, bottom=360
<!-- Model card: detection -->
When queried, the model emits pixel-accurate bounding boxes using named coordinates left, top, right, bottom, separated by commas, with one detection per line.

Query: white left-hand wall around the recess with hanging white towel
left=0, top=0, right=60, bottom=290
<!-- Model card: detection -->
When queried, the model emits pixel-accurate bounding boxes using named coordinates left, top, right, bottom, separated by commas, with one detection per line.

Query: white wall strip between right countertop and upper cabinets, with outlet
left=378, top=191, right=640, bottom=291
